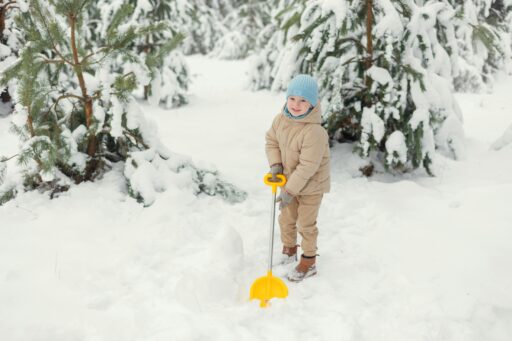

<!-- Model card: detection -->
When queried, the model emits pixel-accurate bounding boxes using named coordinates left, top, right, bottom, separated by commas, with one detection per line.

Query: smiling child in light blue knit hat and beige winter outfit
left=265, top=75, right=330, bottom=282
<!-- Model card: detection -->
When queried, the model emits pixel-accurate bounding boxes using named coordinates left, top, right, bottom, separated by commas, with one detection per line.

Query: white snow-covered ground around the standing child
left=0, top=57, right=512, bottom=341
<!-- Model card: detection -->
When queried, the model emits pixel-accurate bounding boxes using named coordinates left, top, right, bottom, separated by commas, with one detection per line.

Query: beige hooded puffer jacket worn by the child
left=265, top=104, right=331, bottom=196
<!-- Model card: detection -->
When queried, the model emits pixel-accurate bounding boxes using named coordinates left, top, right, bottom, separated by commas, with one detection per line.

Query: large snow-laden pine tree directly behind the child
left=250, top=0, right=463, bottom=173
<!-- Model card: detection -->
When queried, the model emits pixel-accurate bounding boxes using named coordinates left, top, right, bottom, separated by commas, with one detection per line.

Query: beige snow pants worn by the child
left=279, top=194, right=323, bottom=256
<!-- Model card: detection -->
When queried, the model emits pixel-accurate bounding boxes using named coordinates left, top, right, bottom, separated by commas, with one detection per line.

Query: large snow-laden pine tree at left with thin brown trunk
left=0, top=0, right=245, bottom=205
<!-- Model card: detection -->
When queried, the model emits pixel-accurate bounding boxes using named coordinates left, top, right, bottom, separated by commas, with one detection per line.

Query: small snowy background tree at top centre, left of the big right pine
left=211, top=0, right=273, bottom=59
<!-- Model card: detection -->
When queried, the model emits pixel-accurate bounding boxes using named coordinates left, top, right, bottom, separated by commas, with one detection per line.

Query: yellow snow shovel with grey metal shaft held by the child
left=250, top=173, right=288, bottom=308
